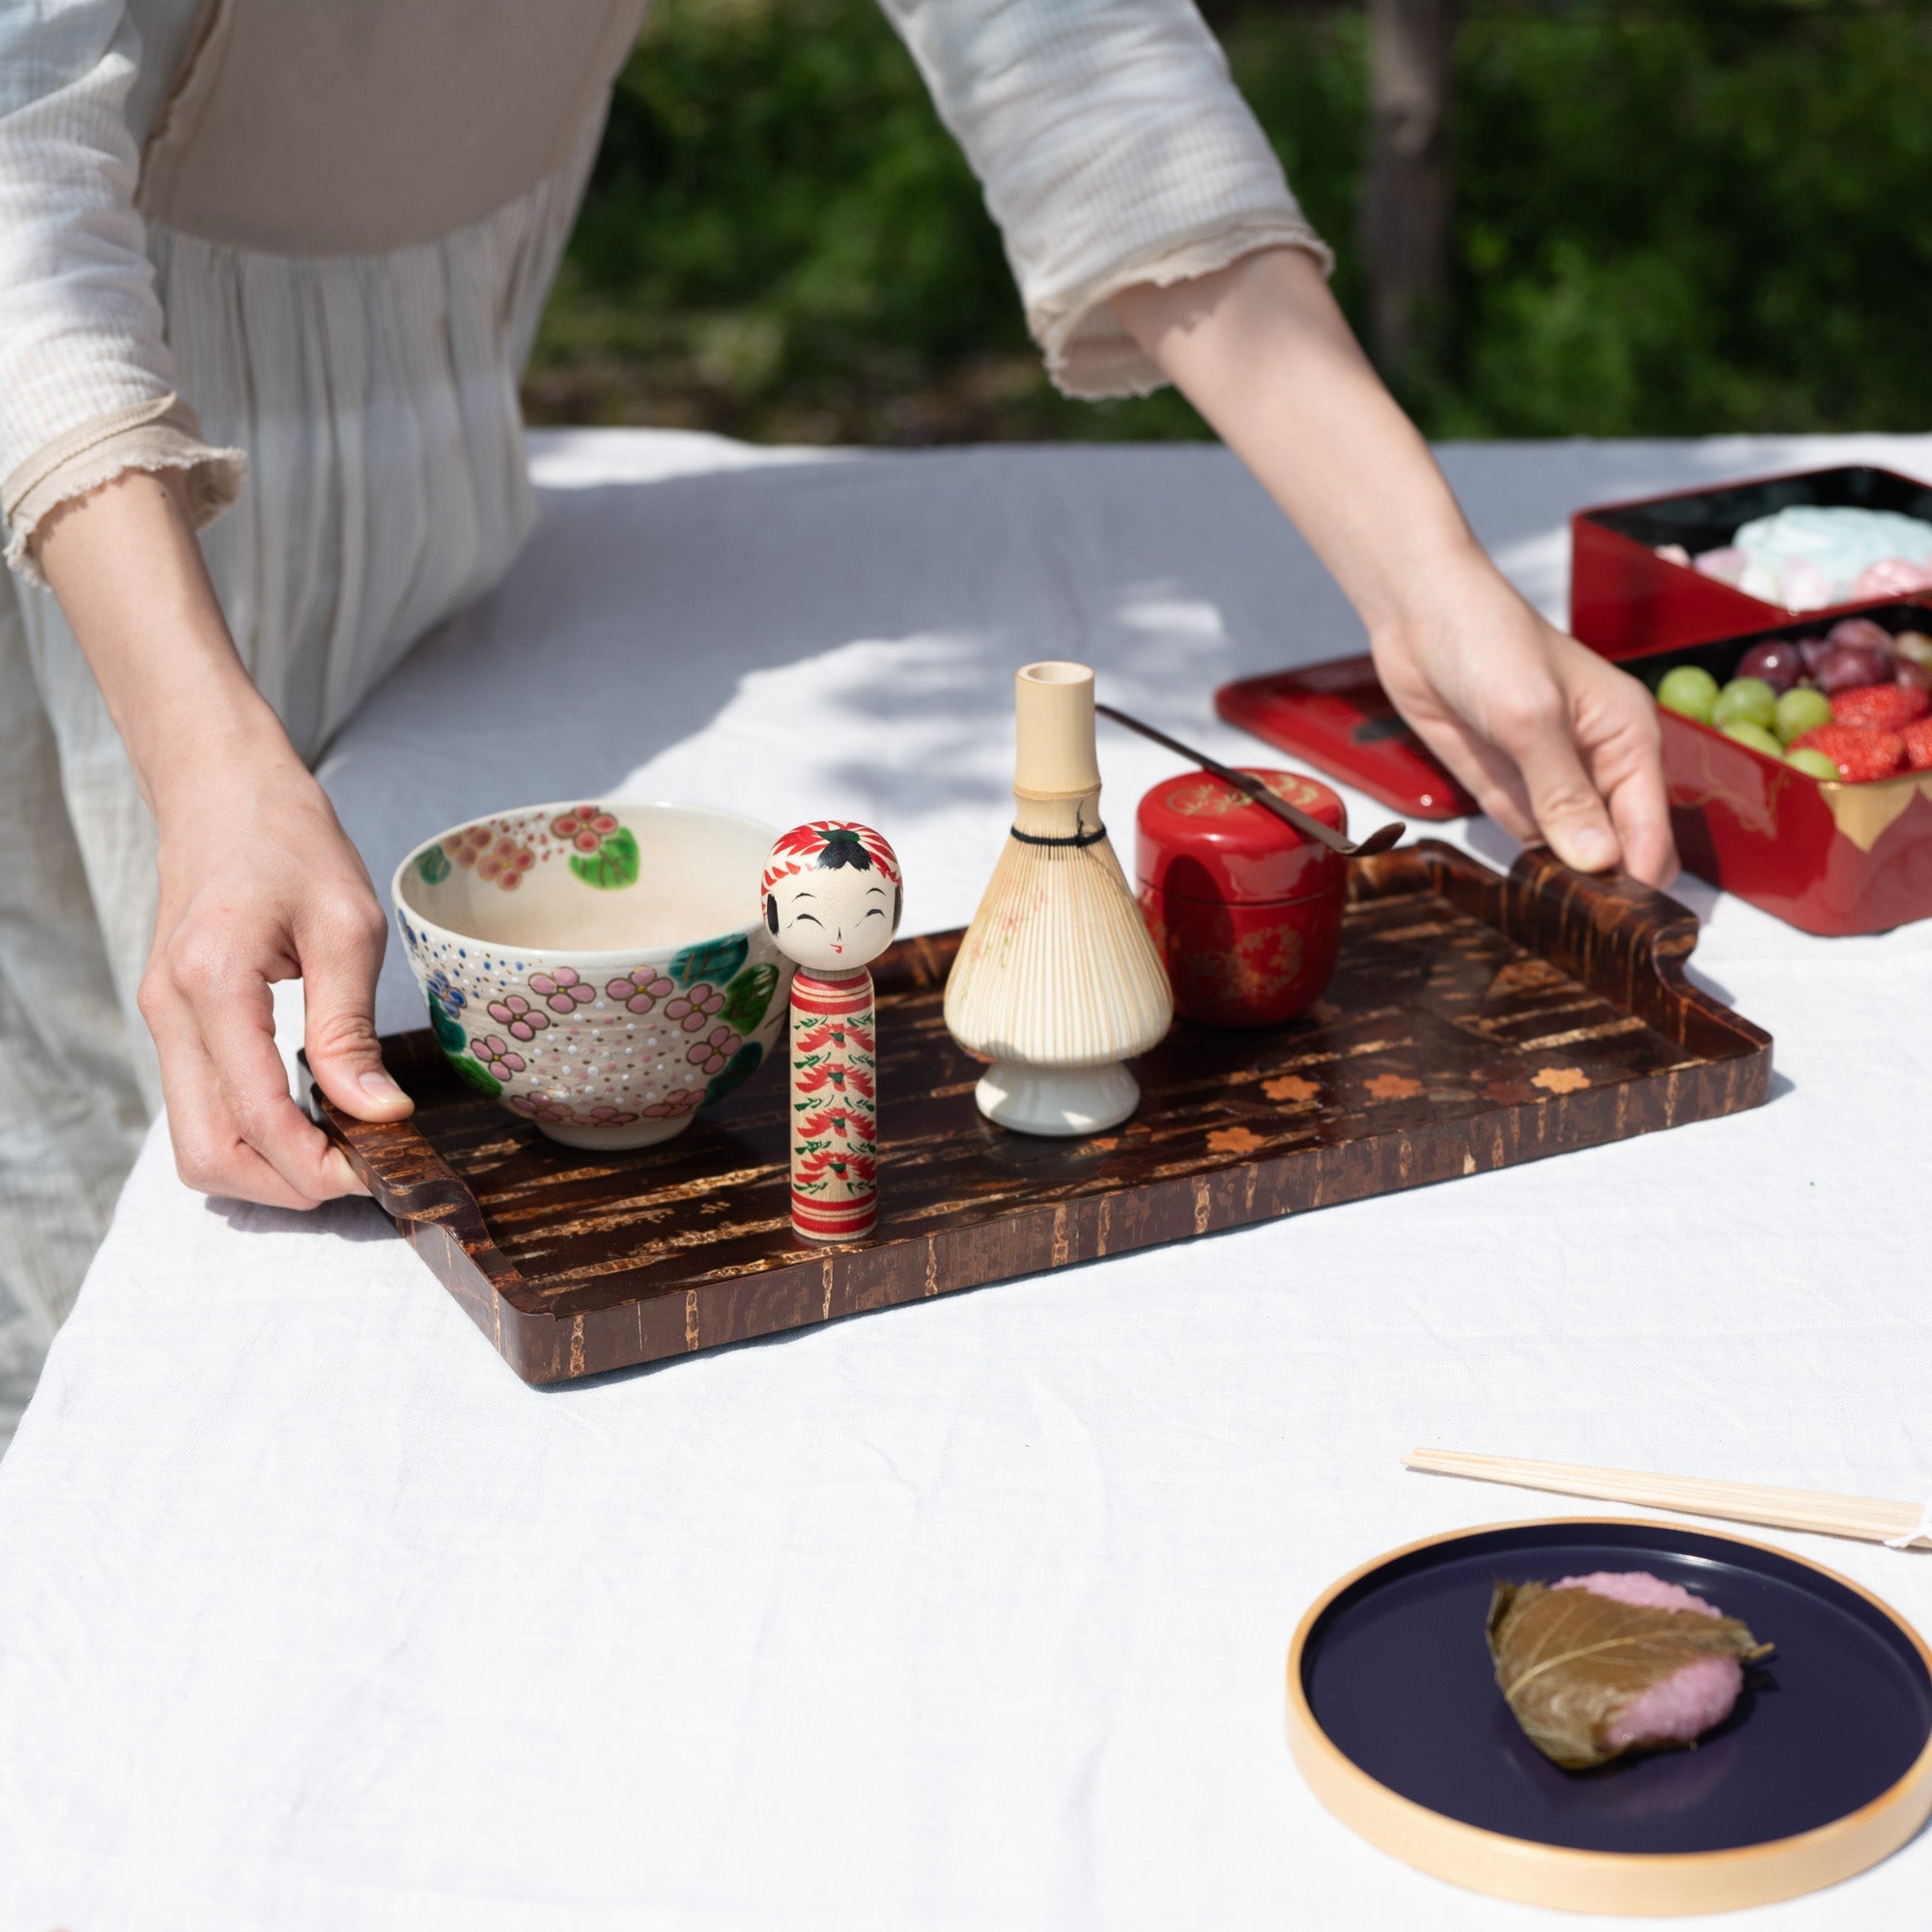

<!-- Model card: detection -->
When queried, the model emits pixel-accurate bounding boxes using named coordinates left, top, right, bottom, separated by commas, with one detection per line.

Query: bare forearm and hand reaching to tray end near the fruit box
left=1113, top=249, right=1677, bottom=885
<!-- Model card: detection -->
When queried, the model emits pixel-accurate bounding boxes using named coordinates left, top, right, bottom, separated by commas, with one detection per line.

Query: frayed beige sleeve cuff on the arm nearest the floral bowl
left=0, top=394, right=247, bottom=583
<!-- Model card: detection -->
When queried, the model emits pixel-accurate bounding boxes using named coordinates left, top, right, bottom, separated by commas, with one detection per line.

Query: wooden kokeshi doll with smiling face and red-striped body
left=761, top=819, right=904, bottom=1240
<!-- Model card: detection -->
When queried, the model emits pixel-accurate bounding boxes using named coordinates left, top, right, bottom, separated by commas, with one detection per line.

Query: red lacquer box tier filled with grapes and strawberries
left=1623, top=601, right=1932, bottom=933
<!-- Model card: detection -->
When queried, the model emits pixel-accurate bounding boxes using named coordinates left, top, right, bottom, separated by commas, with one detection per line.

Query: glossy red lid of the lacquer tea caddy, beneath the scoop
left=1134, top=765, right=1349, bottom=904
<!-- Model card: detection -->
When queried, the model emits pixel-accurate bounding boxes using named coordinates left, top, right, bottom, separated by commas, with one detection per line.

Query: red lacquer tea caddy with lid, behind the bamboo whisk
left=1134, top=767, right=1349, bottom=1026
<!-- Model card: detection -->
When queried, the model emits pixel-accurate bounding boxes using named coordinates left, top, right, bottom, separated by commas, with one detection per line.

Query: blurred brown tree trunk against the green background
left=1362, top=0, right=1457, bottom=375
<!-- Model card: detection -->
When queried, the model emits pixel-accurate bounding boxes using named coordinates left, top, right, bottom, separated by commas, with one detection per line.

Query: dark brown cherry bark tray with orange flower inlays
left=311, top=842, right=1772, bottom=1381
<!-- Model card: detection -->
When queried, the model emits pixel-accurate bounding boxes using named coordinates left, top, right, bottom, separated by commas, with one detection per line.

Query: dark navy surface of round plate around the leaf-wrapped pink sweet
left=1302, top=1522, right=1932, bottom=1853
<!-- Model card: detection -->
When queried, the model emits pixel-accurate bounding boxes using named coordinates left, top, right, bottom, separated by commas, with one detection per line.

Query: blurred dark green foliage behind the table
left=526, top=0, right=1932, bottom=442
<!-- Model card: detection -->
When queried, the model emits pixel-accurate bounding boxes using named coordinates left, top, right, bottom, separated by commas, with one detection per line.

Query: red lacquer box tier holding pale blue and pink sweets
left=1571, top=464, right=1932, bottom=659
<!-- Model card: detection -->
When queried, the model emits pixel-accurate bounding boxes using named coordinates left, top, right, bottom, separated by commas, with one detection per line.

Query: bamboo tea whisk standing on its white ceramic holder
left=945, top=663, right=1173, bottom=1134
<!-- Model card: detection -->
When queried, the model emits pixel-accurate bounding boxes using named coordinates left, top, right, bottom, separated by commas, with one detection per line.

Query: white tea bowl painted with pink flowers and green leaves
left=390, top=804, right=792, bottom=1151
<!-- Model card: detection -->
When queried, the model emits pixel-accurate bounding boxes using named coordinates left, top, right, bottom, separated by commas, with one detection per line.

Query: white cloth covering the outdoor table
left=0, top=433, right=1932, bottom=1932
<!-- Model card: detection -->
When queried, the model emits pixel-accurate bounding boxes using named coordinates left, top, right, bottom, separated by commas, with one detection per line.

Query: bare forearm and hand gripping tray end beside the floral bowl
left=39, top=473, right=412, bottom=1208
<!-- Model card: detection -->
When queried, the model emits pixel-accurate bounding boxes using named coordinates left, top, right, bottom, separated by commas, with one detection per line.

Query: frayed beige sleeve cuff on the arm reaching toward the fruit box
left=1026, top=207, right=1335, bottom=402
